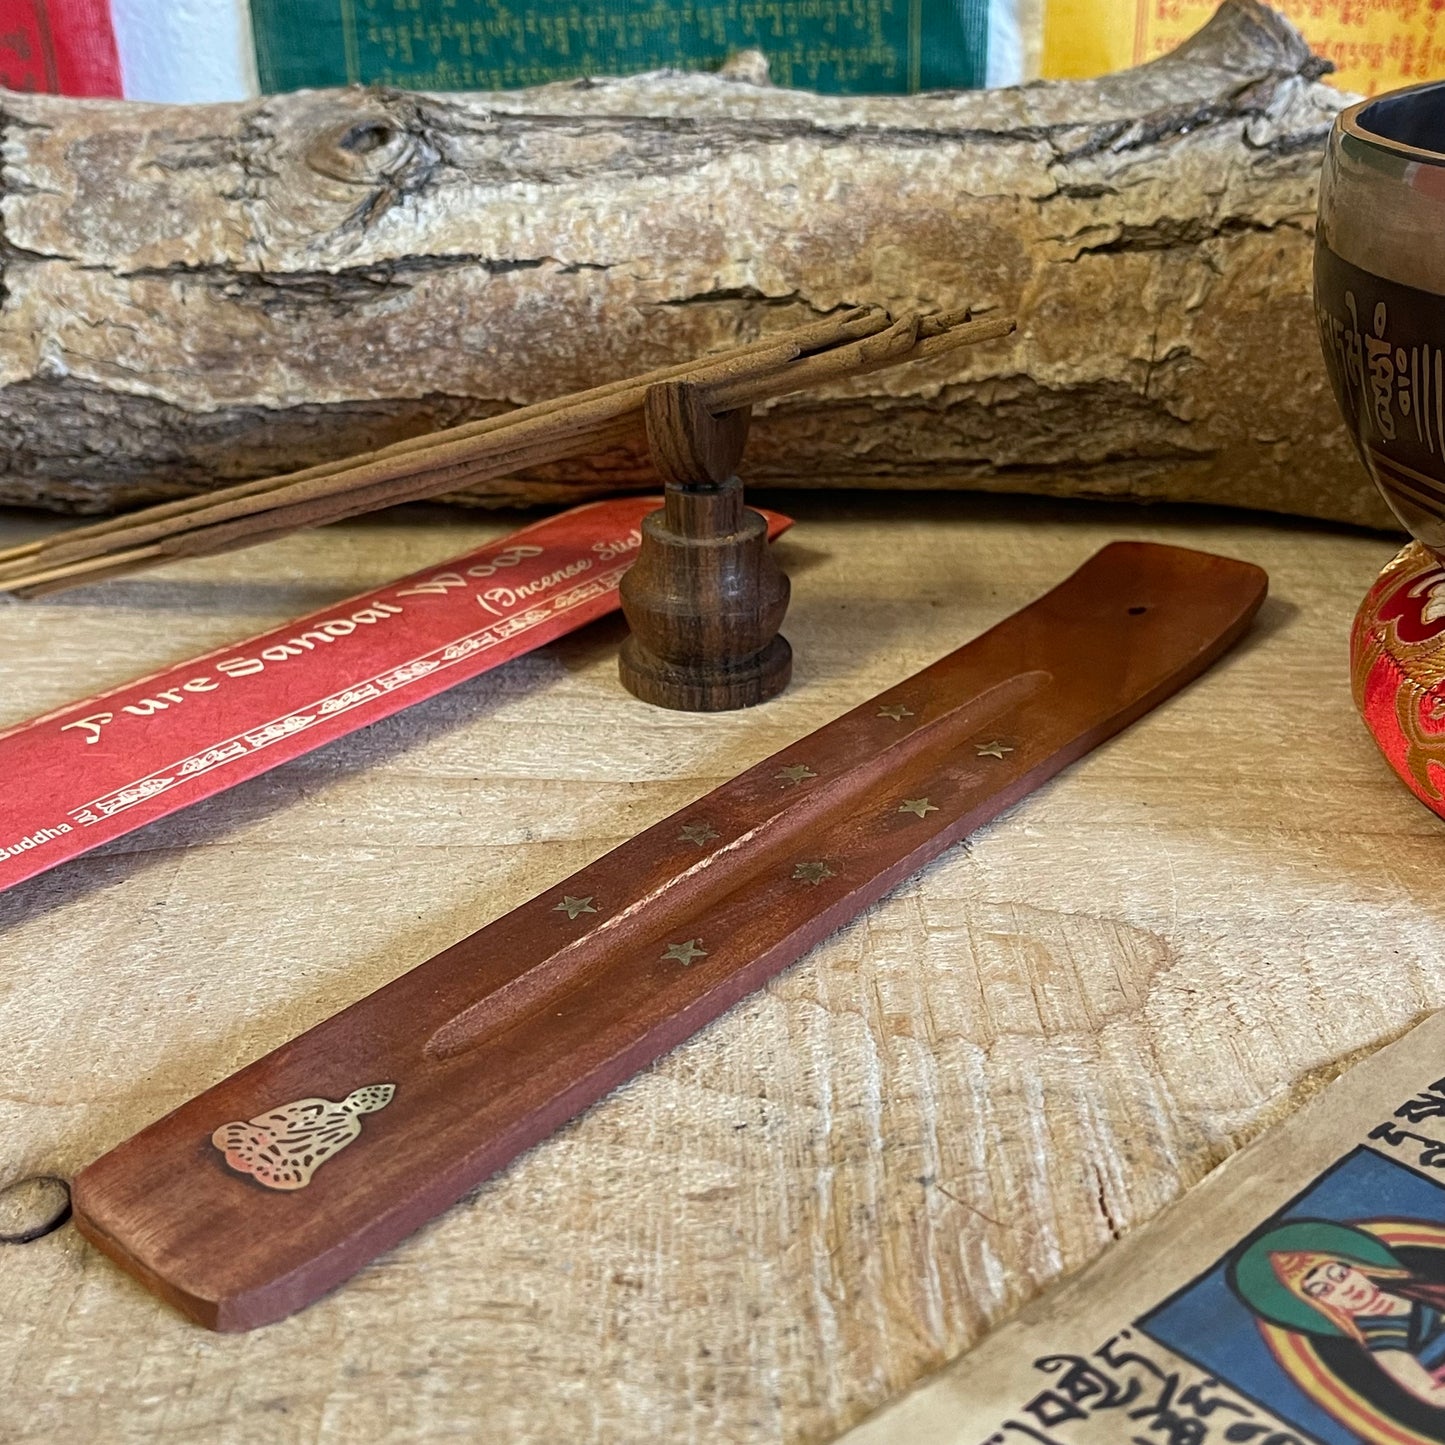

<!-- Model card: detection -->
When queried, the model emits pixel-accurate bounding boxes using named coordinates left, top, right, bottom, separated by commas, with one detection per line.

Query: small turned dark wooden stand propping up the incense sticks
left=618, top=381, right=793, bottom=712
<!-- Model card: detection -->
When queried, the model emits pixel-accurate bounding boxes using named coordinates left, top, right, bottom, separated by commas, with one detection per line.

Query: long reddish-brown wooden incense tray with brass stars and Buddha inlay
left=74, top=543, right=1266, bottom=1329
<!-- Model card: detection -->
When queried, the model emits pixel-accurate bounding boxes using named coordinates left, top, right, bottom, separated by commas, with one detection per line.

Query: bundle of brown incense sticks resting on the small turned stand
left=0, top=306, right=1014, bottom=597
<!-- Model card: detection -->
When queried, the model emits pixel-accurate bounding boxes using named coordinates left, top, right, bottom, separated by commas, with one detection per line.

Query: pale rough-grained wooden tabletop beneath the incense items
left=0, top=497, right=1421, bottom=1445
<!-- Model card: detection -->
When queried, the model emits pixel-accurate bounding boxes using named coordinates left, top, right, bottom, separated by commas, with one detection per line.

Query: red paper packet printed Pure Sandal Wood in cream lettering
left=0, top=497, right=792, bottom=892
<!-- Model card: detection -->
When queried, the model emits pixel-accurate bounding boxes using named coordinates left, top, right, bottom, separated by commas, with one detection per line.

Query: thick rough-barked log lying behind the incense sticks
left=0, top=0, right=1389, bottom=525
